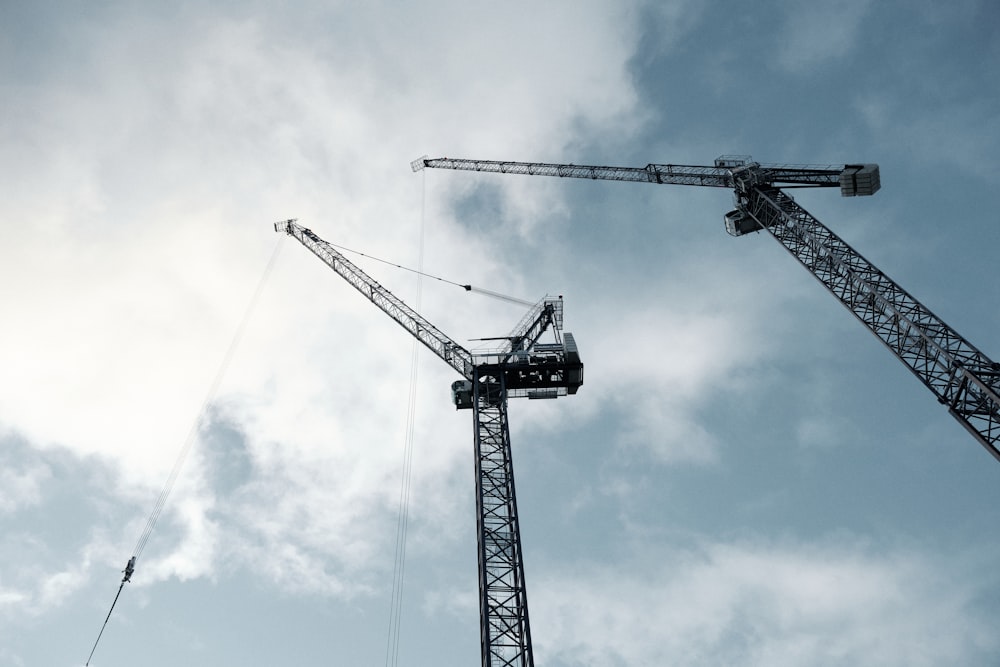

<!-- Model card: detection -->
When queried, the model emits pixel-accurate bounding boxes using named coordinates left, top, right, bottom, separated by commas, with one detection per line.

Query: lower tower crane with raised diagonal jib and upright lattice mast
left=274, top=219, right=583, bottom=667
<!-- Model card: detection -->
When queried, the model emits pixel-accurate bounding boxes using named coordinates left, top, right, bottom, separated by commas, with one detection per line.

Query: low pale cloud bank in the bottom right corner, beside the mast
left=532, top=536, right=998, bottom=666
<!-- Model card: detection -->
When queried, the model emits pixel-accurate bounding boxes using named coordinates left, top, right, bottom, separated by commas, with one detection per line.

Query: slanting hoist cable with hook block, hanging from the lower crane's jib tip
left=86, top=235, right=285, bottom=665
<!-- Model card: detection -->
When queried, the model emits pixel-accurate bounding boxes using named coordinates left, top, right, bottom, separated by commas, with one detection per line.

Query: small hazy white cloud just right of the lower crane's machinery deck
left=574, top=245, right=787, bottom=464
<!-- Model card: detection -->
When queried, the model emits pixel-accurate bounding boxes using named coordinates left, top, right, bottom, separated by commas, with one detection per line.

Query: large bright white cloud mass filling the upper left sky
left=0, top=3, right=637, bottom=604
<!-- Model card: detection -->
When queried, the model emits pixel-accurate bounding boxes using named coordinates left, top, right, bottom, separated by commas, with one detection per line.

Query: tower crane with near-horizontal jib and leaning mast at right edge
left=411, top=155, right=1000, bottom=460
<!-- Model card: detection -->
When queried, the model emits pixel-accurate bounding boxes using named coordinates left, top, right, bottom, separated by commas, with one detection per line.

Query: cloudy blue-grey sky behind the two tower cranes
left=0, top=0, right=1000, bottom=667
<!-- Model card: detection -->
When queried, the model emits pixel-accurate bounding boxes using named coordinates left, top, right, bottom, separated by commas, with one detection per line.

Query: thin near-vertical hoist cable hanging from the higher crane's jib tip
left=380, top=177, right=426, bottom=667
